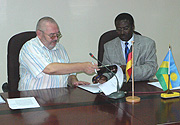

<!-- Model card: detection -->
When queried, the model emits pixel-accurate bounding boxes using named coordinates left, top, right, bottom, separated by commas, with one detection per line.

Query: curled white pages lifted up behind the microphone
left=99, top=65, right=124, bottom=95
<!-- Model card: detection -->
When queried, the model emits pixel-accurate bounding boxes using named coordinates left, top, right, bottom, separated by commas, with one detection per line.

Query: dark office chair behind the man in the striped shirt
left=2, top=31, right=36, bottom=92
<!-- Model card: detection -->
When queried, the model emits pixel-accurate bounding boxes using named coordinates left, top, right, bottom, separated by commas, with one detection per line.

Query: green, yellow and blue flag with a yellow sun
left=156, top=49, right=180, bottom=91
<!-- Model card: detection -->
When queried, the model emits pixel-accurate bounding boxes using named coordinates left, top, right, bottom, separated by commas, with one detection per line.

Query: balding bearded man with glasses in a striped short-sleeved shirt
left=18, top=17, right=99, bottom=91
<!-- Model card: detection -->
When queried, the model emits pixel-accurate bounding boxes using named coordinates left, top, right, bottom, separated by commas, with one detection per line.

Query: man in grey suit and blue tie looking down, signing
left=93, top=13, right=158, bottom=83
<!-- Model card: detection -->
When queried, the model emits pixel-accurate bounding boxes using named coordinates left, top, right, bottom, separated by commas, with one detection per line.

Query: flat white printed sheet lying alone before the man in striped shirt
left=7, top=97, right=40, bottom=109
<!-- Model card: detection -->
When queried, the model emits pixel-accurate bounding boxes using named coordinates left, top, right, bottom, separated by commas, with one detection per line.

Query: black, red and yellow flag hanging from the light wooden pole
left=126, top=46, right=132, bottom=82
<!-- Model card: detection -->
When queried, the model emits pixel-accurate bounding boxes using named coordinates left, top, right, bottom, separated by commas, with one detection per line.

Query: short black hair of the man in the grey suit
left=114, top=13, right=134, bottom=26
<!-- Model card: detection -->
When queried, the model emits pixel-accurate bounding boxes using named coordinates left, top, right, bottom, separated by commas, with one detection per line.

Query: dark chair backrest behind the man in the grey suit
left=98, top=30, right=141, bottom=66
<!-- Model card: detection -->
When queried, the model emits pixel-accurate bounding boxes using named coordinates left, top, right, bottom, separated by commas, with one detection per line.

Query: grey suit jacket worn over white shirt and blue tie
left=102, top=34, right=158, bottom=81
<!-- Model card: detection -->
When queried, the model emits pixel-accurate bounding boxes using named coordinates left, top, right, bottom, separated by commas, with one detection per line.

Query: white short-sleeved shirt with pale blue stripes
left=18, top=37, right=75, bottom=91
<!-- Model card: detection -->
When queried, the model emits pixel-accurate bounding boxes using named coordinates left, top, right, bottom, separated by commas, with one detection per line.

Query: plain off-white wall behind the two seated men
left=0, top=0, right=180, bottom=92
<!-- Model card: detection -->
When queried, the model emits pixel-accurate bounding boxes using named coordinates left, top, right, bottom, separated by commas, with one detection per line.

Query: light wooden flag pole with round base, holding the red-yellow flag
left=126, top=41, right=141, bottom=103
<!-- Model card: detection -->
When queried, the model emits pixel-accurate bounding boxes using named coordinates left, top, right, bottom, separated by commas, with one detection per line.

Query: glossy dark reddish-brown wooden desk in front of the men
left=0, top=82, right=180, bottom=125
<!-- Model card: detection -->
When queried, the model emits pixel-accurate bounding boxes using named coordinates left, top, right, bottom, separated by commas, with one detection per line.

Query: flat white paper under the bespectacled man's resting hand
left=78, top=83, right=101, bottom=93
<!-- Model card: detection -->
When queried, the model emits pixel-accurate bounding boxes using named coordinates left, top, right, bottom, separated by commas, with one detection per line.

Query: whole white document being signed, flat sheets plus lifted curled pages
left=78, top=65, right=124, bottom=95
